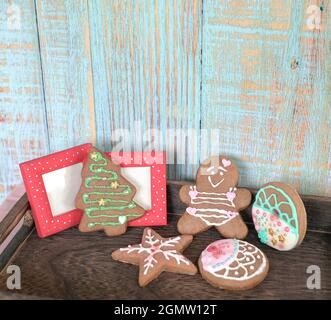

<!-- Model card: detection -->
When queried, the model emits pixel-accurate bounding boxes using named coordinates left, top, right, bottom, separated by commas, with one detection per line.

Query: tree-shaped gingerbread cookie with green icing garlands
left=76, top=147, right=145, bottom=236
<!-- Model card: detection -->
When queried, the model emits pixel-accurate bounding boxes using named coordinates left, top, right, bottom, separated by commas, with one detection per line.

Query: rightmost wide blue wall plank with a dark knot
left=201, top=0, right=331, bottom=196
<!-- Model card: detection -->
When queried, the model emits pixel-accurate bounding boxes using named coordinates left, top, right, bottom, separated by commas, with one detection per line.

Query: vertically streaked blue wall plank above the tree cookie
left=89, top=0, right=202, bottom=179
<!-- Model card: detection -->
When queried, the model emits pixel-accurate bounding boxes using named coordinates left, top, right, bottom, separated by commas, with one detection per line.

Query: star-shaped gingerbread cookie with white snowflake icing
left=112, top=228, right=197, bottom=287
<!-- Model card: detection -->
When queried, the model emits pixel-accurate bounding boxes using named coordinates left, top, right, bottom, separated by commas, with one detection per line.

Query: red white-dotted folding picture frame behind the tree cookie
left=20, top=143, right=167, bottom=238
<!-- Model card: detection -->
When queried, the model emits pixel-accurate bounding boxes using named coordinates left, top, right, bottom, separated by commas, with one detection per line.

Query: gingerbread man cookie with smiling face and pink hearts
left=177, top=156, right=251, bottom=239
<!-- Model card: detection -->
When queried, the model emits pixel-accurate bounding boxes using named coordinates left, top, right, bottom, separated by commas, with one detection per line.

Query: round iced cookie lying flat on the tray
left=199, top=239, right=269, bottom=290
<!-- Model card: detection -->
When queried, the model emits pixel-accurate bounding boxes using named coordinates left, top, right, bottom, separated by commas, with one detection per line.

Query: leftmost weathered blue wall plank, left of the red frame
left=0, top=0, right=49, bottom=200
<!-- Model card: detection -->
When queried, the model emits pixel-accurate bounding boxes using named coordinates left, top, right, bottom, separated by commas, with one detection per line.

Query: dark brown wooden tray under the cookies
left=0, top=181, right=331, bottom=299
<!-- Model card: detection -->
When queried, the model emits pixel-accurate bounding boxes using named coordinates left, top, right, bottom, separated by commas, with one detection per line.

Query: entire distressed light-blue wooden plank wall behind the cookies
left=0, top=0, right=331, bottom=200
